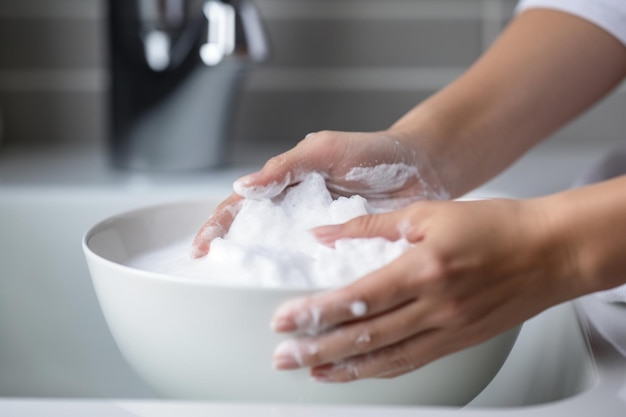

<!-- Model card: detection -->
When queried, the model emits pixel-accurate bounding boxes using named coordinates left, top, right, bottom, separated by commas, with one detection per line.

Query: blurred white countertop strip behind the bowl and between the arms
left=0, top=141, right=608, bottom=197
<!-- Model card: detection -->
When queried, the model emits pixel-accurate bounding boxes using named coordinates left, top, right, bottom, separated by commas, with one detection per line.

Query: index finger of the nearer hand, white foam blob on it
left=271, top=252, right=421, bottom=334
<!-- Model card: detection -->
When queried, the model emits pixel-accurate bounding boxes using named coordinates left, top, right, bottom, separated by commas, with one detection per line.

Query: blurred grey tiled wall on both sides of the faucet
left=0, top=0, right=626, bottom=166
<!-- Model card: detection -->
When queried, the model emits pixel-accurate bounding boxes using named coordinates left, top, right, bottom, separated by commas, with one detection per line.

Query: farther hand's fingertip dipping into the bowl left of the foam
left=191, top=194, right=243, bottom=258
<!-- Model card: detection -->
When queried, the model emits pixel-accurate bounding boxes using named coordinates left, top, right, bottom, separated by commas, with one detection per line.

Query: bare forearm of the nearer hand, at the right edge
left=530, top=176, right=626, bottom=298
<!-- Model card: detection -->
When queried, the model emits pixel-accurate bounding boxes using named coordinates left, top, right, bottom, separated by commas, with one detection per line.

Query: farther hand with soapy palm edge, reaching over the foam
left=193, top=131, right=448, bottom=257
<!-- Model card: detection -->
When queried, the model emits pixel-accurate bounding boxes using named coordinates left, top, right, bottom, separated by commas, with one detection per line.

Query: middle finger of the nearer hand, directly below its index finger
left=274, top=294, right=435, bottom=369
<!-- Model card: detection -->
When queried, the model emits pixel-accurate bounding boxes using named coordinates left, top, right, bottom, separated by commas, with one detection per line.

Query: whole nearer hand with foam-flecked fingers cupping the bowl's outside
left=272, top=199, right=577, bottom=382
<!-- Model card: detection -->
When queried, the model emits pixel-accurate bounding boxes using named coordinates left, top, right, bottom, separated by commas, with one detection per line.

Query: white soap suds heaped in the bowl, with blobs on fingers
left=127, top=174, right=410, bottom=290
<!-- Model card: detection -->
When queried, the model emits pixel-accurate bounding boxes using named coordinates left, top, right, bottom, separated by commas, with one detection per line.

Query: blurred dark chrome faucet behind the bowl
left=108, top=0, right=269, bottom=171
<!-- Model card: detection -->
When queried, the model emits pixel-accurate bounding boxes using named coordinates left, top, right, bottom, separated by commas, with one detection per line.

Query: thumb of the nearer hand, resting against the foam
left=311, top=211, right=407, bottom=246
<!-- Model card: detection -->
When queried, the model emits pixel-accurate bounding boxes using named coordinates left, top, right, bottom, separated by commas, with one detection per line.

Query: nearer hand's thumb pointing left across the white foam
left=312, top=206, right=423, bottom=246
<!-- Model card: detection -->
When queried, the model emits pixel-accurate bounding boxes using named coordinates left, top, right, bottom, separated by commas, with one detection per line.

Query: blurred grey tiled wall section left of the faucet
left=0, top=0, right=106, bottom=149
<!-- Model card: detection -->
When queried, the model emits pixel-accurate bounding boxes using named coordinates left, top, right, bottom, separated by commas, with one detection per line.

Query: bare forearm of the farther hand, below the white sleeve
left=391, top=10, right=626, bottom=197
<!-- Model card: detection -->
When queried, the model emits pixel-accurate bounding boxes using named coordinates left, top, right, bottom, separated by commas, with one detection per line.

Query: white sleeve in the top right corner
left=516, top=0, right=626, bottom=46
